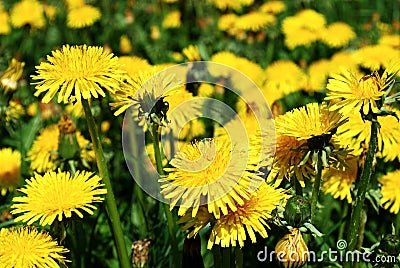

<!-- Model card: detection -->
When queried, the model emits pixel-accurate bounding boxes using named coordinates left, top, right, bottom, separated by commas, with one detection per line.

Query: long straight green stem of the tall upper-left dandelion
left=82, top=99, right=132, bottom=268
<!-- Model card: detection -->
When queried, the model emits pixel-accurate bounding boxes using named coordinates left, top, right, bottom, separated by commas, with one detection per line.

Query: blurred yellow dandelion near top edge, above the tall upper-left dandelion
left=67, top=5, right=101, bottom=28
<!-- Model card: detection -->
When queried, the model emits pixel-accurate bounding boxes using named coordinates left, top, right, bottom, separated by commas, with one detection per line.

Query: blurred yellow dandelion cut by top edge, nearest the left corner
left=10, top=0, right=46, bottom=29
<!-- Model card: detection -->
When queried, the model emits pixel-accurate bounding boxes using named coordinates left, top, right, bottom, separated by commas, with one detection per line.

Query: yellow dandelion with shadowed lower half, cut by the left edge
left=0, top=148, right=21, bottom=195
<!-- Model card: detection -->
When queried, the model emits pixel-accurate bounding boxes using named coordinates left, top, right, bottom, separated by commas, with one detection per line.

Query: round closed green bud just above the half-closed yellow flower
left=283, top=195, right=311, bottom=227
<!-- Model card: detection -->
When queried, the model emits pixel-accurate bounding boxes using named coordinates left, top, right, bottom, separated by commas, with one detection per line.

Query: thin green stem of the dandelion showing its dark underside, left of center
left=151, top=124, right=181, bottom=267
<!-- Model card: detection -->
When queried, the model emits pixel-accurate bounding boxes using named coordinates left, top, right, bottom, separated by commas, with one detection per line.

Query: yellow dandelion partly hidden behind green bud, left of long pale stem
left=27, top=125, right=94, bottom=172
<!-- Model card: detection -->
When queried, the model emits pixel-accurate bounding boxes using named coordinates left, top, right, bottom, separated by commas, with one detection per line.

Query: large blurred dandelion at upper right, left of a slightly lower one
left=282, top=9, right=326, bottom=49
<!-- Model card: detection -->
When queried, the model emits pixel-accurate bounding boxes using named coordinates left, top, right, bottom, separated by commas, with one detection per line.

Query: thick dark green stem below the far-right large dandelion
left=347, top=117, right=379, bottom=251
